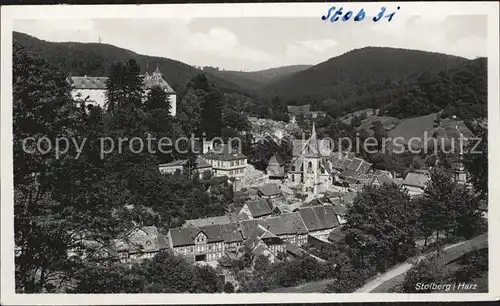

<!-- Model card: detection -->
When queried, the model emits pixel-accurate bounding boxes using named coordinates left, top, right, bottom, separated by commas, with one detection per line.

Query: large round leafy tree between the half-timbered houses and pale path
left=345, top=184, right=417, bottom=269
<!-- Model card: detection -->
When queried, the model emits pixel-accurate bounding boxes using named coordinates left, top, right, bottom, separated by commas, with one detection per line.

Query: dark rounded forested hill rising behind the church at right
left=261, top=47, right=468, bottom=113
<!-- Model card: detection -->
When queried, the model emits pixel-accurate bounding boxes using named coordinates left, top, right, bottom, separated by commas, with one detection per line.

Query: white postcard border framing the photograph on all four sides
left=0, top=2, right=500, bottom=305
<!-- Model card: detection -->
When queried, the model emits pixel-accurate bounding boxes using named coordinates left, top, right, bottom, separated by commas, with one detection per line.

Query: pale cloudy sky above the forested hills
left=14, top=15, right=487, bottom=71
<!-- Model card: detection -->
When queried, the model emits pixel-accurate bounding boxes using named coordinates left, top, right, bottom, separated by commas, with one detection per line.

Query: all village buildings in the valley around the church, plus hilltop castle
left=71, top=69, right=476, bottom=287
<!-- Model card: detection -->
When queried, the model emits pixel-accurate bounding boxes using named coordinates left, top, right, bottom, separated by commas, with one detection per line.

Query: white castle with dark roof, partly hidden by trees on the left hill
left=68, top=67, right=177, bottom=116
